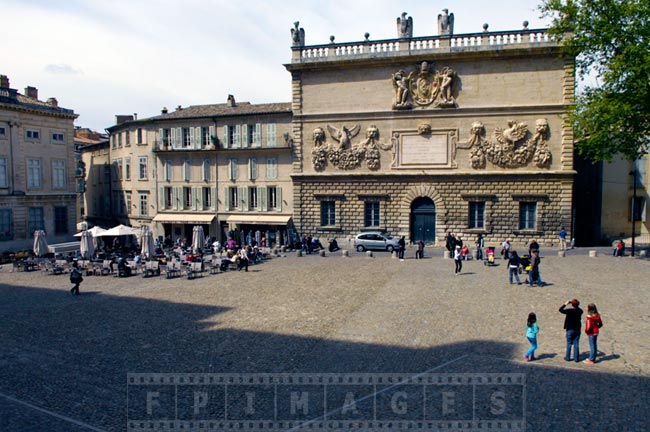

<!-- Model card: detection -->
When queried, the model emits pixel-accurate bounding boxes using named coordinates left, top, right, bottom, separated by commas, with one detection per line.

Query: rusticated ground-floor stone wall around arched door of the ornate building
left=294, top=175, right=572, bottom=246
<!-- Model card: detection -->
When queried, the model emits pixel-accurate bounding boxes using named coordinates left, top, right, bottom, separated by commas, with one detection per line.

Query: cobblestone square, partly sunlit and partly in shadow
left=0, top=249, right=650, bottom=431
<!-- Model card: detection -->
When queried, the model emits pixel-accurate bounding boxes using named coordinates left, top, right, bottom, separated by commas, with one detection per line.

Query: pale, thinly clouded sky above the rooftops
left=0, top=0, right=548, bottom=131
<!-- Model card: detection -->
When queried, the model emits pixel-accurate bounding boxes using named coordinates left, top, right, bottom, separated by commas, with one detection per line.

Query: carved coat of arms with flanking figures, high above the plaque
left=391, top=62, right=456, bottom=110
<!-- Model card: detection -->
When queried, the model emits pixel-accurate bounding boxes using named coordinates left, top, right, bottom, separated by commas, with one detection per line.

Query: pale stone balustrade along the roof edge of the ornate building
left=292, top=29, right=557, bottom=63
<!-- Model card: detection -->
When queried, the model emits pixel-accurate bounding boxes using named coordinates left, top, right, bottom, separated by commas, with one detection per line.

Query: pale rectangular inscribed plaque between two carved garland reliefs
left=400, top=133, right=449, bottom=166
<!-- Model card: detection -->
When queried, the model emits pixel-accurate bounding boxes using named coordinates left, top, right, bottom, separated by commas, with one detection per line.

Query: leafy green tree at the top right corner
left=539, top=0, right=650, bottom=161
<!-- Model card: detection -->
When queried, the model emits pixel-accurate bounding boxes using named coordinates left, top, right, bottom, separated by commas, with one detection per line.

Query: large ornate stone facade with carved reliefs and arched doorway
left=285, top=17, right=575, bottom=248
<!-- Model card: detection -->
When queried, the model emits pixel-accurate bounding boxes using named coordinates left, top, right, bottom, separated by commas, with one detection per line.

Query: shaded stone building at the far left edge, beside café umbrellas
left=0, top=75, right=77, bottom=251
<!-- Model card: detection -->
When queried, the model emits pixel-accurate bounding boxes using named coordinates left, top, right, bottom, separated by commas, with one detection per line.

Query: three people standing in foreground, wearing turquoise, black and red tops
left=524, top=299, right=603, bottom=364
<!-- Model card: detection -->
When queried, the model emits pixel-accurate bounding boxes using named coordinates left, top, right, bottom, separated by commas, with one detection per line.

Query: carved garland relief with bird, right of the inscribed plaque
left=467, top=119, right=552, bottom=169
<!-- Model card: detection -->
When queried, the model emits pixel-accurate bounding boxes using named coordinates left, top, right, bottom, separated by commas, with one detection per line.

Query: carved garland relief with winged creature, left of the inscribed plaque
left=311, top=124, right=393, bottom=171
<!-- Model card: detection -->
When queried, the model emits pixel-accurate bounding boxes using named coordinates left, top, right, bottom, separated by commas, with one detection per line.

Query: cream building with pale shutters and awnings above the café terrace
left=101, top=96, right=293, bottom=245
